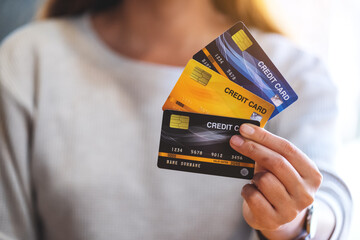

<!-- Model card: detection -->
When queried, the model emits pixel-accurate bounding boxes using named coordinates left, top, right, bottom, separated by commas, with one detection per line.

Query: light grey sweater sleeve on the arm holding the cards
left=267, top=52, right=352, bottom=239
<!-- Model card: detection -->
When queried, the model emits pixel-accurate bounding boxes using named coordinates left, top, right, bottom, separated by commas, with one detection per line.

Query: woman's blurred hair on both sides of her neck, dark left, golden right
left=39, top=0, right=283, bottom=34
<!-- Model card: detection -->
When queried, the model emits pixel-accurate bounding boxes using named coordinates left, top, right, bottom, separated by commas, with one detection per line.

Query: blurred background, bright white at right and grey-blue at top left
left=0, top=0, right=360, bottom=240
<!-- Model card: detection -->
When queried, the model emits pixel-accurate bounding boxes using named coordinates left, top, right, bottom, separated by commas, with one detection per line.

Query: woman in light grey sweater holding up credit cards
left=0, top=0, right=350, bottom=240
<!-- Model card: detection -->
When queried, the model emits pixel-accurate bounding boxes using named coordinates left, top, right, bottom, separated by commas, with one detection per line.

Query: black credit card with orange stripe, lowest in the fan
left=158, top=110, right=259, bottom=179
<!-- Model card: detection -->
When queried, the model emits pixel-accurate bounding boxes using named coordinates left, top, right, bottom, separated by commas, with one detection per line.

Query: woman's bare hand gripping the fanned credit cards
left=230, top=124, right=322, bottom=240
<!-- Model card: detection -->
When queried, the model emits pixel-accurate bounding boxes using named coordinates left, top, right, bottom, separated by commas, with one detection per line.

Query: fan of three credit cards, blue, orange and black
left=158, top=22, right=298, bottom=179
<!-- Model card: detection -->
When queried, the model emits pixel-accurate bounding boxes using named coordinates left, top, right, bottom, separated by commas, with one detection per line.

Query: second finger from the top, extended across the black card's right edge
left=230, top=135, right=303, bottom=196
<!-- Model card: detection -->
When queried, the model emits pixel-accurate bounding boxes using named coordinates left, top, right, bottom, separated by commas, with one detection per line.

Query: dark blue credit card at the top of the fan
left=193, top=22, right=298, bottom=119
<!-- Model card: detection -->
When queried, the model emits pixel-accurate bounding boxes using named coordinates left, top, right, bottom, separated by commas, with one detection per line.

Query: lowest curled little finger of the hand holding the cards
left=241, top=184, right=278, bottom=230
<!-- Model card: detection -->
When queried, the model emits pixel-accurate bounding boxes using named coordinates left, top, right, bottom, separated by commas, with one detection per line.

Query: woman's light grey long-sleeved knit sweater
left=0, top=15, right=350, bottom=240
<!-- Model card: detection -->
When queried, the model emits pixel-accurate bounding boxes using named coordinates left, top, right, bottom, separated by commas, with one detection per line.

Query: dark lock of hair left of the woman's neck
left=39, top=0, right=122, bottom=18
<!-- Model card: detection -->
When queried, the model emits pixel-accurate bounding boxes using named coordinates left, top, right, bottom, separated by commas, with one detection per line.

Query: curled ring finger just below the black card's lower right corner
left=252, top=172, right=301, bottom=223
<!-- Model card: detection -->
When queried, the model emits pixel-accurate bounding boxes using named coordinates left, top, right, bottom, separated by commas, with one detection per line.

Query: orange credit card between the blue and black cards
left=163, top=59, right=275, bottom=127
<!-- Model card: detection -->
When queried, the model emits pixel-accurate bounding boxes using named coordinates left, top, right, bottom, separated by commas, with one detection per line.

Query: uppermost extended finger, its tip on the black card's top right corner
left=239, top=124, right=318, bottom=178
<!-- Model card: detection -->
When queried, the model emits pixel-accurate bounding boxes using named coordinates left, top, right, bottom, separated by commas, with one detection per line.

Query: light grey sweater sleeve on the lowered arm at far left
left=0, top=33, right=37, bottom=240
